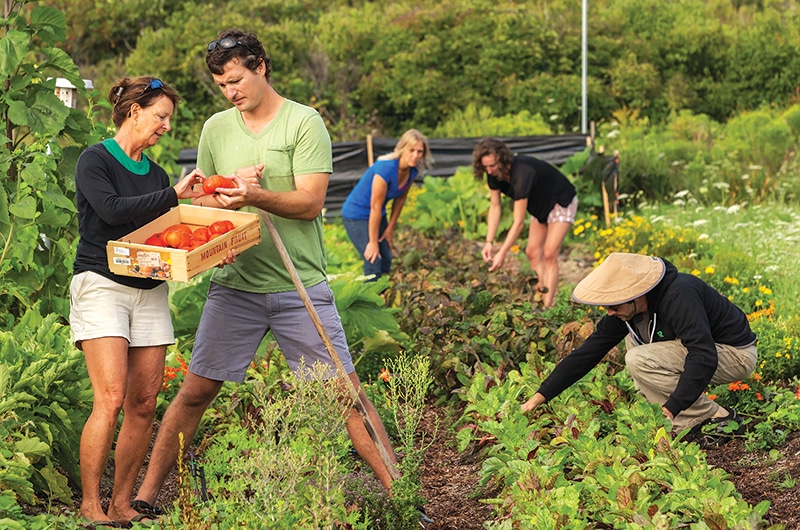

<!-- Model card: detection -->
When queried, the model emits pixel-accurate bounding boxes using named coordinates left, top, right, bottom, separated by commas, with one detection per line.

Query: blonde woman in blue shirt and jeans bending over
left=342, top=129, right=433, bottom=278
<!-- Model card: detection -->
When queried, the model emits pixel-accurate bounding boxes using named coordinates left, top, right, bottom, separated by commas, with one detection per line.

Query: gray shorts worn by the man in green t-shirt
left=189, top=282, right=354, bottom=383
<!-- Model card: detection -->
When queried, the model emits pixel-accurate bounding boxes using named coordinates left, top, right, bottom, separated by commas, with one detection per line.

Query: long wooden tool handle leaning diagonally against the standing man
left=258, top=208, right=400, bottom=479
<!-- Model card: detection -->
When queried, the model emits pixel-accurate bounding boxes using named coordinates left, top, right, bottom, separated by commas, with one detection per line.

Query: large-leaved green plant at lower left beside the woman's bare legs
left=0, top=305, right=92, bottom=504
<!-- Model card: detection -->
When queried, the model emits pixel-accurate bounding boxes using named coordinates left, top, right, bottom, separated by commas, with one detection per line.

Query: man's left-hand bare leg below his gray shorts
left=136, top=372, right=222, bottom=504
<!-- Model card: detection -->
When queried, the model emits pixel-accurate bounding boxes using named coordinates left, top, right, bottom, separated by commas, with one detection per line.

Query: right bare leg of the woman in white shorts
left=108, top=346, right=167, bottom=521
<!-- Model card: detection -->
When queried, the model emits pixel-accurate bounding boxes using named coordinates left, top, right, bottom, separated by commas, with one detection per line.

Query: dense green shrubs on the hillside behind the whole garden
left=44, top=0, right=800, bottom=145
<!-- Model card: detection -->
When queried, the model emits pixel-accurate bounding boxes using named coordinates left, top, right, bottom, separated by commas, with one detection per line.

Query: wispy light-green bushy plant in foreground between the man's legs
left=203, top=364, right=366, bottom=528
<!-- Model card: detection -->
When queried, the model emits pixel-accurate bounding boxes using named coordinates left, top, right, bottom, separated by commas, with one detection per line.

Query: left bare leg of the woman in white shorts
left=80, top=337, right=128, bottom=521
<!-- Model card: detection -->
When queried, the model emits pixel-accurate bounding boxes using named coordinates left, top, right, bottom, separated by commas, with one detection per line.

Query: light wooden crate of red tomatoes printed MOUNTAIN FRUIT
left=106, top=204, right=261, bottom=282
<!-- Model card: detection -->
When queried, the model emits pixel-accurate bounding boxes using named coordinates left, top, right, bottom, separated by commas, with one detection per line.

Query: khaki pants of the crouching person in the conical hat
left=625, top=337, right=758, bottom=433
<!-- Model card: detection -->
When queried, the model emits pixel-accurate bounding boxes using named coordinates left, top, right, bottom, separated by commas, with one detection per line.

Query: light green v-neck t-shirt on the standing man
left=197, top=99, right=333, bottom=293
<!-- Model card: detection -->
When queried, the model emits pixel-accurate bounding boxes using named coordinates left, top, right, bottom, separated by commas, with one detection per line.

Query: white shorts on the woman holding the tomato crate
left=69, top=272, right=175, bottom=348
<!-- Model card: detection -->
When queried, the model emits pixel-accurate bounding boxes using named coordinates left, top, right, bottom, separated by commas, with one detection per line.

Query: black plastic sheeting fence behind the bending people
left=178, top=134, right=589, bottom=216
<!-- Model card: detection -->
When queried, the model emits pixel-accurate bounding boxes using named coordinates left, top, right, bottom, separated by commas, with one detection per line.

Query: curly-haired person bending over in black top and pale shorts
left=472, top=138, right=578, bottom=308
